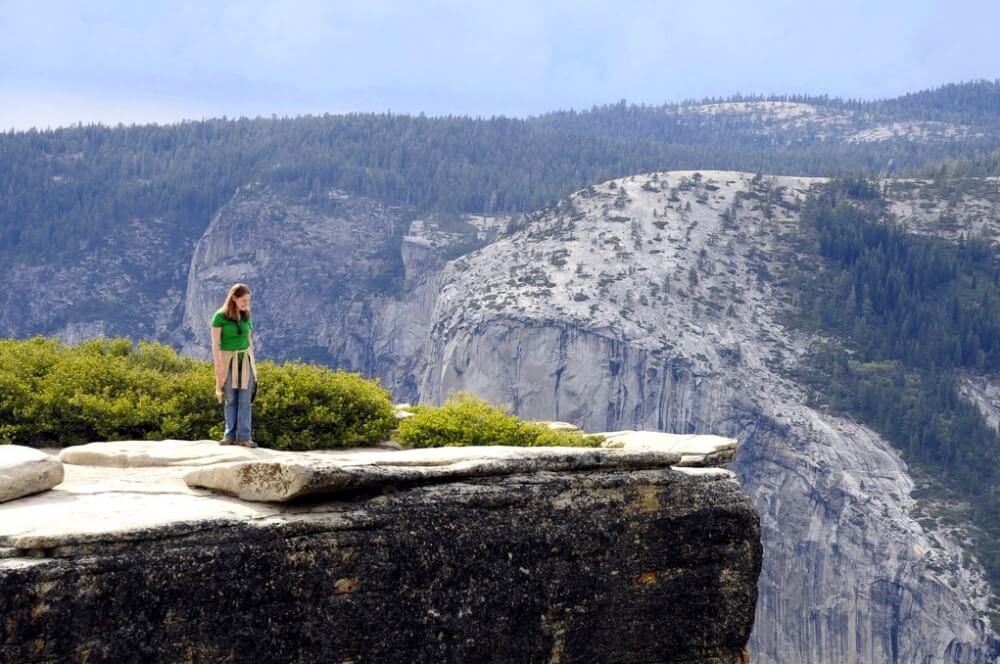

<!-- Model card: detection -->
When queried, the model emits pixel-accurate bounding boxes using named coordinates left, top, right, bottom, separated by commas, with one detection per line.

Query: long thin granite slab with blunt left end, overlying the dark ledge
left=184, top=446, right=680, bottom=502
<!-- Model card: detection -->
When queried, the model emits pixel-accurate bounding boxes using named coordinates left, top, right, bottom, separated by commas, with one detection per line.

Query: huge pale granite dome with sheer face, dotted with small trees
left=408, top=172, right=1000, bottom=662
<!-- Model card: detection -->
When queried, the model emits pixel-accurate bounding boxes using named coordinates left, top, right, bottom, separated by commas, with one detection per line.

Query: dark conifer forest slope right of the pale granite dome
left=786, top=178, right=1000, bottom=624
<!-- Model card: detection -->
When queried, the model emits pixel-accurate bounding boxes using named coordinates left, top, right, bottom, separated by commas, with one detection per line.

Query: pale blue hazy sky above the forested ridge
left=0, top=0, right=1000, bottom=130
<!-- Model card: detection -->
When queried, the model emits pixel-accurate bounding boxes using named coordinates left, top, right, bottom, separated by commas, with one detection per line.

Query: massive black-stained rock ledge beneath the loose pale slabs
left=0, top=440, right=761, bottom=664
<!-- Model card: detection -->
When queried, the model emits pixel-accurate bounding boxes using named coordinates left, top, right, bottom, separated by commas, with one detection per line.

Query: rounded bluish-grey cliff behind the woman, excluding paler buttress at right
left=184, top=186, right=403, bottom=369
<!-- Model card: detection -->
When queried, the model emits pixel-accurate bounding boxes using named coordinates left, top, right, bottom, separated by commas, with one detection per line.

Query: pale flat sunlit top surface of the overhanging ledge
left=0, top=441, right=735, bottom=559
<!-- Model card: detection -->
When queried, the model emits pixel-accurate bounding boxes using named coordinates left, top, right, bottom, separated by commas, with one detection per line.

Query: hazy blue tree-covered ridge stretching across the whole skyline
left=0, top=83, right=1000, bottom=265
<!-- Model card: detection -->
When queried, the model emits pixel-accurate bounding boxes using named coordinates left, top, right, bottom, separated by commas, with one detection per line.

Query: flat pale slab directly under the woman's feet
left=59, top=440, right=274, bottom=468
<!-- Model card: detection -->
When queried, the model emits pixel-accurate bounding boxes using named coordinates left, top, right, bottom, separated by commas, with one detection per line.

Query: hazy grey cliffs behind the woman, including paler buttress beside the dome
left=176, top=185, right=505, bottom=400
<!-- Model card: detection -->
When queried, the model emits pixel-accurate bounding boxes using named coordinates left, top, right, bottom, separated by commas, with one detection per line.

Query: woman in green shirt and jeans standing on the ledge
left=212, top=284, right=257, bottom=447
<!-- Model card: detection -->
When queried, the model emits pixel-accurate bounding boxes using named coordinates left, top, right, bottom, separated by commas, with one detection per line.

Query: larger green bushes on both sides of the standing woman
left=0, top=337, right=395, bottom=449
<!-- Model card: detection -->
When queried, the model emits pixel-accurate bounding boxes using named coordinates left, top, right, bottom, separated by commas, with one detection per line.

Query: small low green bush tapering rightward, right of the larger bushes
left=394, top=392, right=604, bottom=447
